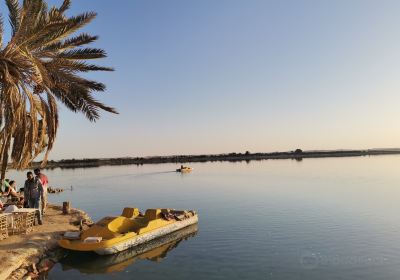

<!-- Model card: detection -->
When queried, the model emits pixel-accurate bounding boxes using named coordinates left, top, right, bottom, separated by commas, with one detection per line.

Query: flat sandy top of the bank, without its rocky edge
left=0, top=205, right=90, bottom=279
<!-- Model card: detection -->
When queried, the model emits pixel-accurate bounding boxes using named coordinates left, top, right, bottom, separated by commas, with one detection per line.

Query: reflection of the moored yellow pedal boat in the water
left=60, top=224, right=198, bottom=274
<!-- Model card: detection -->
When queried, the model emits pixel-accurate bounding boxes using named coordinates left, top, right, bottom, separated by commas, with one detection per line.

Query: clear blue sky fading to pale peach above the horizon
left=0, top=0, right=400, bottom=159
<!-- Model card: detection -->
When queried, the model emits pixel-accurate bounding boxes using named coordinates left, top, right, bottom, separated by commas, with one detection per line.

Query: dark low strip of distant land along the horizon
left=32, top=149, right=400, bottom=169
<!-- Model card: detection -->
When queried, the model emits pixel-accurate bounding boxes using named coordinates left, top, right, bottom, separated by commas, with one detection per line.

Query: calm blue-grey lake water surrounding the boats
left=7, top=156, right=400, bottom=280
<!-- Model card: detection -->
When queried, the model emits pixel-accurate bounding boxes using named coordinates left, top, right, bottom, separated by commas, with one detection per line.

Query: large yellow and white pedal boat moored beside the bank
left=58, top=208, right=198, bottom=255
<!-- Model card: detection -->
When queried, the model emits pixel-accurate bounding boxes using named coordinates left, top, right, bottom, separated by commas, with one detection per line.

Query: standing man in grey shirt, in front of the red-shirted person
left=24, top=171, right=43, bottom=225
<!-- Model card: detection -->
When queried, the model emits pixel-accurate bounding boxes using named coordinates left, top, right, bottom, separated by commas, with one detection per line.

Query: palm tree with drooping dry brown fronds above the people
left=0, top=0, right=117, bottom=180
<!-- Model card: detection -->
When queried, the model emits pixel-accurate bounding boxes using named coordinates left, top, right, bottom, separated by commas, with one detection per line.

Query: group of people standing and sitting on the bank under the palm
left=0, top=168, right=49, bottom=225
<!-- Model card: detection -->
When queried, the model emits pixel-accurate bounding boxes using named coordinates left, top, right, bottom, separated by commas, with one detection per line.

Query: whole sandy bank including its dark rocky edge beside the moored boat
left=0, top=205, right=91, bottom=280
